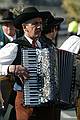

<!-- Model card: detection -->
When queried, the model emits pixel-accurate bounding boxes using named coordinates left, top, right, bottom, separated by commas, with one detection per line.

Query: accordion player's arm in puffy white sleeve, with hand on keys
left=0, top=43, right=29, bottom=82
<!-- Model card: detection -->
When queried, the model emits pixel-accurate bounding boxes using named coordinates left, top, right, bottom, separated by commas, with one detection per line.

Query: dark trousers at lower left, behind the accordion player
left=1, top=80, right=16, bottom=120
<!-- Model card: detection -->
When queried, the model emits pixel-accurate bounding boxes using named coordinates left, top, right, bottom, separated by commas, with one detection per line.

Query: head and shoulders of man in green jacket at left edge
left=0, top=10, right=22, bottom=48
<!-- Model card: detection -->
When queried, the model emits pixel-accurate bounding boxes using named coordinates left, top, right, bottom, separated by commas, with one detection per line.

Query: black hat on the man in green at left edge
left=0, top=10, right=14, bottom=24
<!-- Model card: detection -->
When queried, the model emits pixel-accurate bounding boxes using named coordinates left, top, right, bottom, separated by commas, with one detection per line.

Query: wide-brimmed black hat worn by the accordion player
left=15, top=7, right=51, bottom=28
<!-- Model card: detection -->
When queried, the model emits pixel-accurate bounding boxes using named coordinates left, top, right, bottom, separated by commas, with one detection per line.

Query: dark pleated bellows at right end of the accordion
left=58, top=50, right=76, bottom=104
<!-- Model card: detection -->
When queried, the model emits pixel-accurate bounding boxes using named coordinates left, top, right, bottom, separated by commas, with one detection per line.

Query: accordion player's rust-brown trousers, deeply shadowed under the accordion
left=15, top=91, right=60, bottom=120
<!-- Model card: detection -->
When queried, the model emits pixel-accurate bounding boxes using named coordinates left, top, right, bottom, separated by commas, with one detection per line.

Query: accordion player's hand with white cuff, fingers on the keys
left=9, top=65, right=29, bottom=83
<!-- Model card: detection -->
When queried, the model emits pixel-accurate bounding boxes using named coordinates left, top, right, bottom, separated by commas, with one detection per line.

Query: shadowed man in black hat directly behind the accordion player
left=41, top=12, right=64, bottom=47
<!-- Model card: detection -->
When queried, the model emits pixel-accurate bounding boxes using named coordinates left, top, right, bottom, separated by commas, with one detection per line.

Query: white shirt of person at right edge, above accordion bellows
left=59, top=35, right=80, bottom=54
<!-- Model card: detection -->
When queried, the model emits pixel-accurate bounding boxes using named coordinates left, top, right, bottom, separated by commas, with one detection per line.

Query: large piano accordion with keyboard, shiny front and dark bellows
left=21, top=48, right=76, bottom=107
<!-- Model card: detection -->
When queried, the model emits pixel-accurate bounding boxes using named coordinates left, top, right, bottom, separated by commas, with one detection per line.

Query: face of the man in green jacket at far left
left=2, top=23, right=16, bottom=36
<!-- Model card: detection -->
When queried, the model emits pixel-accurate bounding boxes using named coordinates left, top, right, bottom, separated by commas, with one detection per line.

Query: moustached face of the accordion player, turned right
left=23, top=17, right=42, bottom=40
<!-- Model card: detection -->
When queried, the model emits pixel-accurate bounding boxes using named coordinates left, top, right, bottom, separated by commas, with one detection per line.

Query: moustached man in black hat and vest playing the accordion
left=0, top=7, right=63, bottom=120
